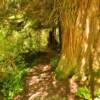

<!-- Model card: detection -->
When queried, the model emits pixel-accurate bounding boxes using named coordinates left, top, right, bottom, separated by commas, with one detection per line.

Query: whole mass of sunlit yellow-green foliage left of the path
left=0, top=12, right=47, bottom=100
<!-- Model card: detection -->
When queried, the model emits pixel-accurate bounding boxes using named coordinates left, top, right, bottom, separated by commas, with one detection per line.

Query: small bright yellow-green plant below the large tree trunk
left=76, top=87, right=91, bottom=100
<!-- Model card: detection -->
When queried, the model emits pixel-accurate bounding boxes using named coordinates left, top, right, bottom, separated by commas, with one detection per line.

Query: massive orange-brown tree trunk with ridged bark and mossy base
left=56, top=0, right=100, bottom=100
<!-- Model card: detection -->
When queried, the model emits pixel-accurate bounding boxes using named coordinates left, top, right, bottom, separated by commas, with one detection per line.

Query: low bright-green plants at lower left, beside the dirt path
left=1, top=69, right=28, bottom=100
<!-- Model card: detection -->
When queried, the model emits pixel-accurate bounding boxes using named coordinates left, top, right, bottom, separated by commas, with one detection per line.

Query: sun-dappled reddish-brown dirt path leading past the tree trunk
left=14, top=49, right=67, bottom=100
